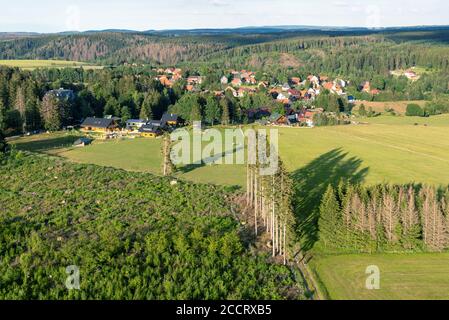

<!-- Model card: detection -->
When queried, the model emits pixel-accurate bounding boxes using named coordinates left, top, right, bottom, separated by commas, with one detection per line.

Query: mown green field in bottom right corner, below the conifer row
left=309, top=253, right=449, bottom=300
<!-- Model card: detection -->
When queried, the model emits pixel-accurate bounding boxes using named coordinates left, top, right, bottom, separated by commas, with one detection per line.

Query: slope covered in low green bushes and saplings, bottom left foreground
left=0, top=154, right=303, bottom=299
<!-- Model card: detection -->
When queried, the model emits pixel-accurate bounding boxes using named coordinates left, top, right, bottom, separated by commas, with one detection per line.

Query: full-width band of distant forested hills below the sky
left=0, top=27, right=449, bottom=65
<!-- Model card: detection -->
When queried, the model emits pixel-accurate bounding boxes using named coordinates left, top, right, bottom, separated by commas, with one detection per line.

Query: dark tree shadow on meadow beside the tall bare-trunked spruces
left=293, top=149, right=369, bottom=251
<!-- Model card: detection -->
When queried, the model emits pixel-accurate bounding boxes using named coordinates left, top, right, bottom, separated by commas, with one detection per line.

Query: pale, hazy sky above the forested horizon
left=0, top=0, right=449, bottom=32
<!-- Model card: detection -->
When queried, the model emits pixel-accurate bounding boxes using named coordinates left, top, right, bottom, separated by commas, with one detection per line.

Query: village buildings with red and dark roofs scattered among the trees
left=54, top=67, right=380, bottom=146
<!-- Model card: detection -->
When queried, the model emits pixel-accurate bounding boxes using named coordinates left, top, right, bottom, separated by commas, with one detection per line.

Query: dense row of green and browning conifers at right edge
left=318, top=185, right=449, bottom=252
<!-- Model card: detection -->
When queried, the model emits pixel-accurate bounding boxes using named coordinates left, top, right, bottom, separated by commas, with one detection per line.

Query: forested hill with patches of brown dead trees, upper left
left=0, top=32, right=231, bottom=64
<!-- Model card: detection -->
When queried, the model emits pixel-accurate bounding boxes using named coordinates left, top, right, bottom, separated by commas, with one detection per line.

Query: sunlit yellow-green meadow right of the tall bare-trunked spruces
left=280, top=115, right=449, bottom=185
